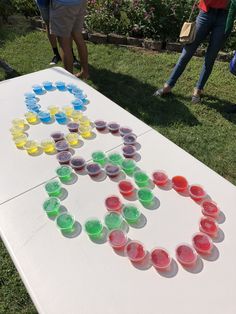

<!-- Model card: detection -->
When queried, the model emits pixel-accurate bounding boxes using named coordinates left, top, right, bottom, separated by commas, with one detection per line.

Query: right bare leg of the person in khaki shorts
left=72, top=32, right=89, bottom=79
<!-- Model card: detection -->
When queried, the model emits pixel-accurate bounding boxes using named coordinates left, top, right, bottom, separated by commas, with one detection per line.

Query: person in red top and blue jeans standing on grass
left=154, top=0, right=235, bottom=103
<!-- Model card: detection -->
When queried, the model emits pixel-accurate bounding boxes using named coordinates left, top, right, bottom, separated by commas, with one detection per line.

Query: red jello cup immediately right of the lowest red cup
left=175, top=243, right=197, bottom=268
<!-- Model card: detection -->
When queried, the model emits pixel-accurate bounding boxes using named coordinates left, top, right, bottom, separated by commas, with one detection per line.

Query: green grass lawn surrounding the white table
left=0, top=15, right=236, bottom=313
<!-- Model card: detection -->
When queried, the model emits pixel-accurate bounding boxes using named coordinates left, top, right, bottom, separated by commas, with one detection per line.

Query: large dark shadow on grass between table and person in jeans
left=90, top=66, right=199, bottom=126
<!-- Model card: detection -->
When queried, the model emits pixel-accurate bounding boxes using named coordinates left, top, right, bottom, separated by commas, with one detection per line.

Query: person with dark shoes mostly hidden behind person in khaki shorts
left=35, top=0, right=79, bottom=66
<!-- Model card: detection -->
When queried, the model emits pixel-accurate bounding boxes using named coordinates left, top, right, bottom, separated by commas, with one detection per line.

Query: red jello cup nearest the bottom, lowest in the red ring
left=150, top=247, right=172, bottom=272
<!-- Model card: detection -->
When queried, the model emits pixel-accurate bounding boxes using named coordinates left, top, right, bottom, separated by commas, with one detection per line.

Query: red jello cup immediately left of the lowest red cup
left=125, top=241, right=147, bottom=263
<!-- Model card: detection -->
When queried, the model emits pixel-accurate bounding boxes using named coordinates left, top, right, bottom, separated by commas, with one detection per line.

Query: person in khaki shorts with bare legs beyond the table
left=50, top=0, right=89, bottom=79
